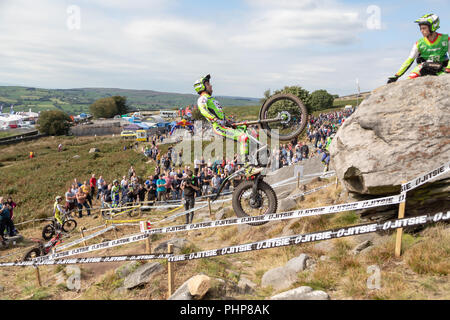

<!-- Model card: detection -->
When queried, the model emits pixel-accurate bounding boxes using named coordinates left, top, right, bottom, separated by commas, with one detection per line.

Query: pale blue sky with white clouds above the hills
left=0, top=0, right=450, bottom=97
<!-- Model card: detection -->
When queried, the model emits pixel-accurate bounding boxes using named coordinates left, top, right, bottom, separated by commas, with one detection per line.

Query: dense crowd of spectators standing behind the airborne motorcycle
left=51, top=109, right=353, bottom=222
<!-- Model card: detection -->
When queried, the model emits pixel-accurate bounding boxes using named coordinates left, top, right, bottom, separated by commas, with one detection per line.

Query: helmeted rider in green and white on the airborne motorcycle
left=194, top=74, right=262, bottom=176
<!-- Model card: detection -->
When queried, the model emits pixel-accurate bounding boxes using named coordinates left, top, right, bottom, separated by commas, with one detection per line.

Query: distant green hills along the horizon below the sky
left=0, top=86, right=259, bottom=115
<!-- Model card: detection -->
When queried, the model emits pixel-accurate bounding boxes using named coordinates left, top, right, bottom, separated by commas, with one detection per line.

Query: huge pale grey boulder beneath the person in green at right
left=330, top=75, right=450, bottom=218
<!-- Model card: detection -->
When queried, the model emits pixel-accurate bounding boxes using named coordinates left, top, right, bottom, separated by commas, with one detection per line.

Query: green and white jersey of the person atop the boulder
left=395, top=33, right=450, bottom=77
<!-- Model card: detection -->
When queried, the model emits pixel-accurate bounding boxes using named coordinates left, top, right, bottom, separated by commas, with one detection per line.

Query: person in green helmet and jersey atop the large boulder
left=387, top=14, right=450, bottom=83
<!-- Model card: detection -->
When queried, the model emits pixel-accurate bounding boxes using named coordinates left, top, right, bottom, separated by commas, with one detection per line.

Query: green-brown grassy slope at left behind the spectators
left=0, top=137, right=174, bottom=222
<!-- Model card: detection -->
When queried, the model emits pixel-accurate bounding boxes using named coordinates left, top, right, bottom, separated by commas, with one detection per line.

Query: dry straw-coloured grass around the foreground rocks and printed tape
left=0, top=171, right=450, bottom=300
